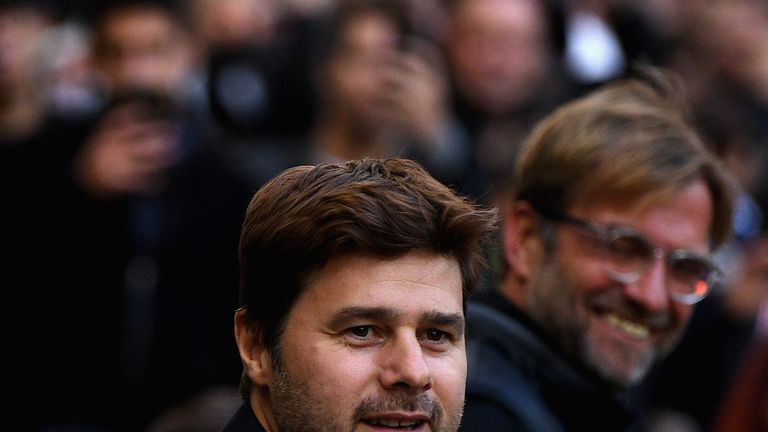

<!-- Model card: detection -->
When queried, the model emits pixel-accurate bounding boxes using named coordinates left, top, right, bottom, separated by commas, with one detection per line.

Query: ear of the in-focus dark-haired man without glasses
left=235, top=309, right=272, bottom=386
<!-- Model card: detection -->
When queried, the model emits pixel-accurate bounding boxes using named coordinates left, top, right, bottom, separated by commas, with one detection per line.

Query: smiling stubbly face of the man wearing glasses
left=525, top=181, right=712, bottom=387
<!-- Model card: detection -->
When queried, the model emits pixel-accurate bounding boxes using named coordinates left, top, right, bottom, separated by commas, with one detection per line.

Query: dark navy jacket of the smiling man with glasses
left=460, top=292, right=634, bottom=432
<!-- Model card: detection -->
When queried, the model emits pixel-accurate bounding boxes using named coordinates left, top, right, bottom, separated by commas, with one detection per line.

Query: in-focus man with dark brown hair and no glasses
left=226, top=159, right=496, bottom=432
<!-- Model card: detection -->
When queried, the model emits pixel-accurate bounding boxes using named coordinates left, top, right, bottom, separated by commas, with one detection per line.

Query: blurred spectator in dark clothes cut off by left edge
left=0, top=0, right=90, bottom=266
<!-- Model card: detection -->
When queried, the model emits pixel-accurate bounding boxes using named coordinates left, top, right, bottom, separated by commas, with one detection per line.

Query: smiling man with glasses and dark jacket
left=462, top=70, right=733, bottom=431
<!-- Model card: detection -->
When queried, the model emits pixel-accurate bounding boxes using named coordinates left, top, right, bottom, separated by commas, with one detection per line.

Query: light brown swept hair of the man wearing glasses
left=514, top=67, right=734, bottom=247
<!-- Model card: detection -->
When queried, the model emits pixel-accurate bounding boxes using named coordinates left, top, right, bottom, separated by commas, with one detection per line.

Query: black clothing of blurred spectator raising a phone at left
left=6, top=107, right=252, bottom=431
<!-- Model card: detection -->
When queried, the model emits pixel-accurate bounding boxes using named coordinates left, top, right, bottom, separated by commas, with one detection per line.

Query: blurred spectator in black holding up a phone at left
left=14, top=1, right=250, bottom=430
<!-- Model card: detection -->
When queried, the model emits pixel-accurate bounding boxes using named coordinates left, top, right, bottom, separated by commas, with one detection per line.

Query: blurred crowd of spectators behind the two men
left=0, top=0, right=768, bottom=431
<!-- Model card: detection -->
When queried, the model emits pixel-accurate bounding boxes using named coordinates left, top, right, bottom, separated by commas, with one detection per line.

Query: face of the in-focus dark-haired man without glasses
left=269, top=252, right=466, bottom=432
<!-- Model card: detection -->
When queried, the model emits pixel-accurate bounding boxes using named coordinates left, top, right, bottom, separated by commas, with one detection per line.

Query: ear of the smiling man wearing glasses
left=503, top=201, right=541, bottom=283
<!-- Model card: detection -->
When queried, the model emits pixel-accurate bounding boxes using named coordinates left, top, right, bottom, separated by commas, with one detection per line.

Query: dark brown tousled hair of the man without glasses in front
left=240, top=159, right=497, bottom=396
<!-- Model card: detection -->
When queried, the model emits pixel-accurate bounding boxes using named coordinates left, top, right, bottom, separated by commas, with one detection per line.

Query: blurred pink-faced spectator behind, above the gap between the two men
left=446, top=0, right=573, bottom=202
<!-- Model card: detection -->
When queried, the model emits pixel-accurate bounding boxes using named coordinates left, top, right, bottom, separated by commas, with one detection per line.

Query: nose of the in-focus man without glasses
left=380, top=332, right=432, bottom=393
